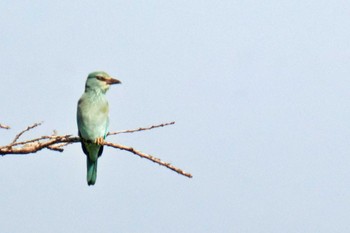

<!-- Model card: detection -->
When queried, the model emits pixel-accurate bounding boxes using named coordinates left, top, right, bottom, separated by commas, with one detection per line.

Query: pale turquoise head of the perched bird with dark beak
left=85, top=71, right=121, bottom=93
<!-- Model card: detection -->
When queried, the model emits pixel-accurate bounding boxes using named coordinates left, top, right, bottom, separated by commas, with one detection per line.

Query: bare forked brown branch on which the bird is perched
left=0, top=122, right=192, bottom=178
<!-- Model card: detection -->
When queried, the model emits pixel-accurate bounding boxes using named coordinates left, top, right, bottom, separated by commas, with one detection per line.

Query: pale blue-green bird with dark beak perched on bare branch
left=77, top=71, right=121, bottom=185
